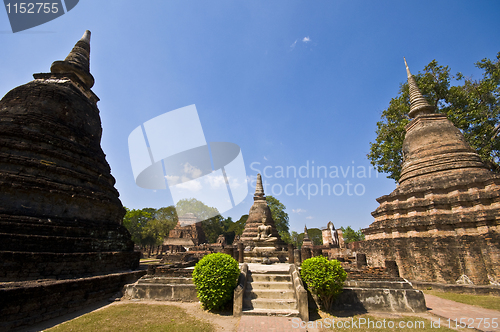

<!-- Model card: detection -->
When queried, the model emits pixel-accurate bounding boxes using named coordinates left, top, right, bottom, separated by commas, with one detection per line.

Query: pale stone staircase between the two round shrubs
left=242, top=266, right=299, bottom=317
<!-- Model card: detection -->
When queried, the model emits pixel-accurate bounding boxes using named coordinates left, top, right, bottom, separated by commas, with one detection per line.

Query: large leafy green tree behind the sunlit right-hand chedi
left=367, top=52, right=500, bottom=181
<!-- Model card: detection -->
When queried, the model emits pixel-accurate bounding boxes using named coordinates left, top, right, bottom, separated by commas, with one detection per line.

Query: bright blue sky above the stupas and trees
left=0, top=0, right=500, bottom=231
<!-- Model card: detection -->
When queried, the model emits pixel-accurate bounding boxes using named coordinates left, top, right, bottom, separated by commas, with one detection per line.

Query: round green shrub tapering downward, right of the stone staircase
left=300, top=256, right=347, bottom=311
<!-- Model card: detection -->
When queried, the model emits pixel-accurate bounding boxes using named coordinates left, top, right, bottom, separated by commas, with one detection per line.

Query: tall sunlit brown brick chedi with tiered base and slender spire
left=359, top=60, right=500, bottom=284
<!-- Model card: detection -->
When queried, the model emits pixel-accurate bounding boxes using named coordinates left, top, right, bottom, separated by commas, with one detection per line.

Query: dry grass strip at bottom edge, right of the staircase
left=318, top=314, right=462, bottom=332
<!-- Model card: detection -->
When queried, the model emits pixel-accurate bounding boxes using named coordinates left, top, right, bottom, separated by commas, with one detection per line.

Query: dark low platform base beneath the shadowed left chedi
left=0, top=271, right=146, bottom=331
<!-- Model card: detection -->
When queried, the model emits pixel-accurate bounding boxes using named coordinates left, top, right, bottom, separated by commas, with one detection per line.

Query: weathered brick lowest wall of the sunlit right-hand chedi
left=352, top=231, right=500, bottom=285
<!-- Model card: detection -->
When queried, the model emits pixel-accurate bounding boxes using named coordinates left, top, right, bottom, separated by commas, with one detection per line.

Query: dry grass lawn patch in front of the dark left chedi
left=46, top=303, right=215, bottom=332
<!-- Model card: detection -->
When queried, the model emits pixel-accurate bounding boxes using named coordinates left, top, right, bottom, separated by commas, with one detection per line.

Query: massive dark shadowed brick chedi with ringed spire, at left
left=0, top=31, right=139, bottom=281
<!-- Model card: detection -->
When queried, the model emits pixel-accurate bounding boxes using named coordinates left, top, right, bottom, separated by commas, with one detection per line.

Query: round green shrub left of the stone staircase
left=193, top=253, right=240, bottom=310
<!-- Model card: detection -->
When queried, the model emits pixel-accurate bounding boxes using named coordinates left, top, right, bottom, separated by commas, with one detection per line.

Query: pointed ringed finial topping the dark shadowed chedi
left=50, top=30, right=94, bottom=89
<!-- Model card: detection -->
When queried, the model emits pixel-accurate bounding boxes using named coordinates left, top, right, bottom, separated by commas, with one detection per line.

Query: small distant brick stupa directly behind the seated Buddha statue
left=240, top=174, right=285, bottom=246
